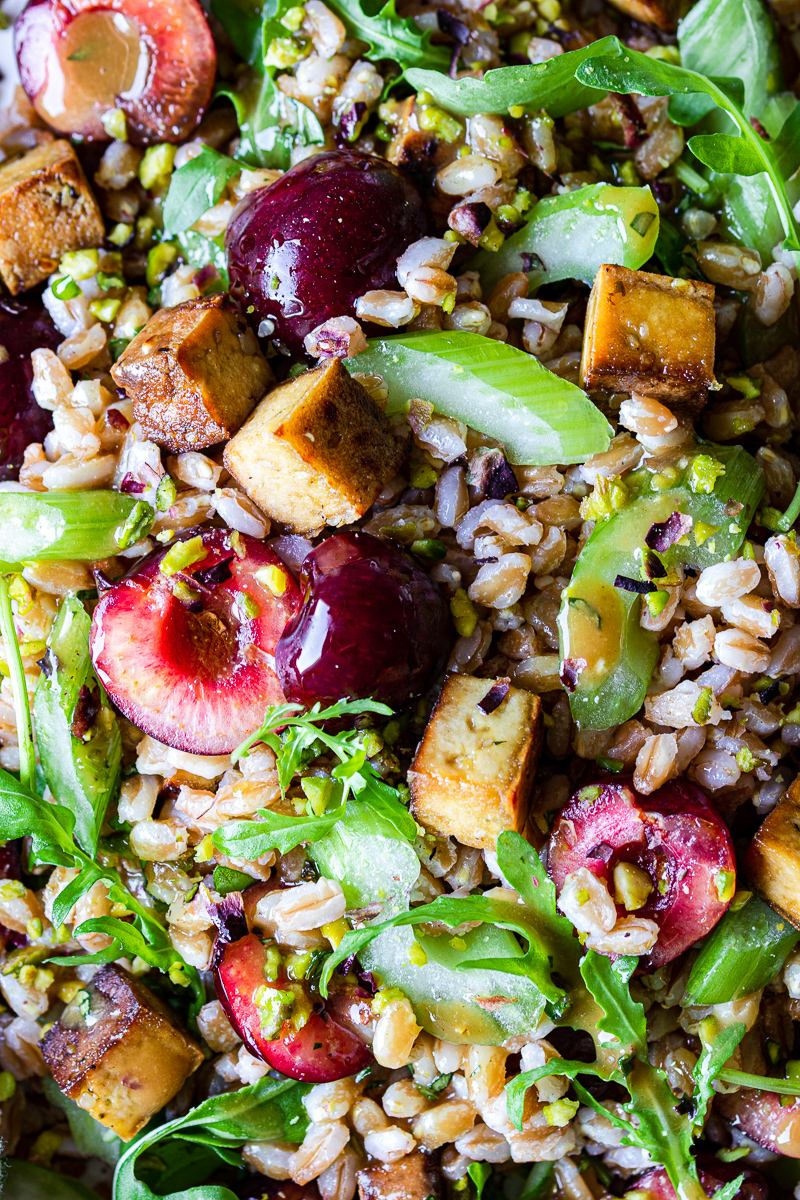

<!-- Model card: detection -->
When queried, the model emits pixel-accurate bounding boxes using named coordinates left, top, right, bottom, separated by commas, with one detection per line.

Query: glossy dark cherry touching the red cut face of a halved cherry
left=275, top=533, right=452, bottom=708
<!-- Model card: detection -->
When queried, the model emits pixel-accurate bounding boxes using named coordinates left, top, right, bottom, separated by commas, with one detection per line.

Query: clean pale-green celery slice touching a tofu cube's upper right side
left=343, top=331, right=612, bottom=466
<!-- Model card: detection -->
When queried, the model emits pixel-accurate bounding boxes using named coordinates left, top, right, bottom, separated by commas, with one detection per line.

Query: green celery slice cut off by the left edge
left=0, top=491, right=155, bottom=571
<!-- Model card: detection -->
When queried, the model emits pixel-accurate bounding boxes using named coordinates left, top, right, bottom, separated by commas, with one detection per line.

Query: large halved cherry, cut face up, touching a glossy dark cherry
left=91, top=529, right=300, bottom=755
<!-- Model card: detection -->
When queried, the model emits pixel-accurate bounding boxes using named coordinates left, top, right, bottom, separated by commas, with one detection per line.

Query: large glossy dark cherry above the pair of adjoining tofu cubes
left=225, top=150, right=432, bottom=354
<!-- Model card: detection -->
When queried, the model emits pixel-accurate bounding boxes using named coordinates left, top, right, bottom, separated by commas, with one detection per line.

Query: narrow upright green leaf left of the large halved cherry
left=34, top=593, right=122, bottom=854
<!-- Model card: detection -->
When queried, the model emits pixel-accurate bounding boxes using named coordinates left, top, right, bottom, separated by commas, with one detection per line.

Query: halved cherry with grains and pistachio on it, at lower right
left=547, top=781, right=736, bottom=971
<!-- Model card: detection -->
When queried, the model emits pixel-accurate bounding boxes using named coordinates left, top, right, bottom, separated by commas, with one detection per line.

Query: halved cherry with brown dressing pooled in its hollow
left=14, top=0, right=217, bottom=145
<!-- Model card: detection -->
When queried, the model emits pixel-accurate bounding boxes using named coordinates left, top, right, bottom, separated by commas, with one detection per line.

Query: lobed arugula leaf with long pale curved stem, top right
left=576, top=42, right=800, bottom=251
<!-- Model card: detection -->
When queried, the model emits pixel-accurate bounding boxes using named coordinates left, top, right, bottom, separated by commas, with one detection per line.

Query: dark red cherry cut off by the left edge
left=0, top=299, right=64, bottom=479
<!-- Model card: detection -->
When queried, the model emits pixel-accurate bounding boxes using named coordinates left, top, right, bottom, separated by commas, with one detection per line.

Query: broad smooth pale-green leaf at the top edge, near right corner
left=678, top=0, right=782, bottom=116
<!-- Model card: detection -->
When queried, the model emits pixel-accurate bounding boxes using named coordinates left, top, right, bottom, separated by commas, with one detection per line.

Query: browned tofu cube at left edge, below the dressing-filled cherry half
left=0, top=140, right=104, bottom=295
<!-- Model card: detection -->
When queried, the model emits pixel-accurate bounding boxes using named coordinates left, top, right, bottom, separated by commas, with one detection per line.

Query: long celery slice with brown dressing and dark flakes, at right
left=558, top=443, right=764, bottom=730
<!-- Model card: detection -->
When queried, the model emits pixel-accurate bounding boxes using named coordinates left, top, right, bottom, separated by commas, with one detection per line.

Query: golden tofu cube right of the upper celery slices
left=581, top=264, right=715, bottom=415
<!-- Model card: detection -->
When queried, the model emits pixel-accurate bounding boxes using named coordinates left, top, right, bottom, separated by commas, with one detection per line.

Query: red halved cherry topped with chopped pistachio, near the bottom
left=213, top=934, right=372, bottom=1084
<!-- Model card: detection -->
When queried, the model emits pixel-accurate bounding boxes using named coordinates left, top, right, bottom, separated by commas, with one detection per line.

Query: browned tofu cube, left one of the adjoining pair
left=112, top=295, right=275, bottom=452
